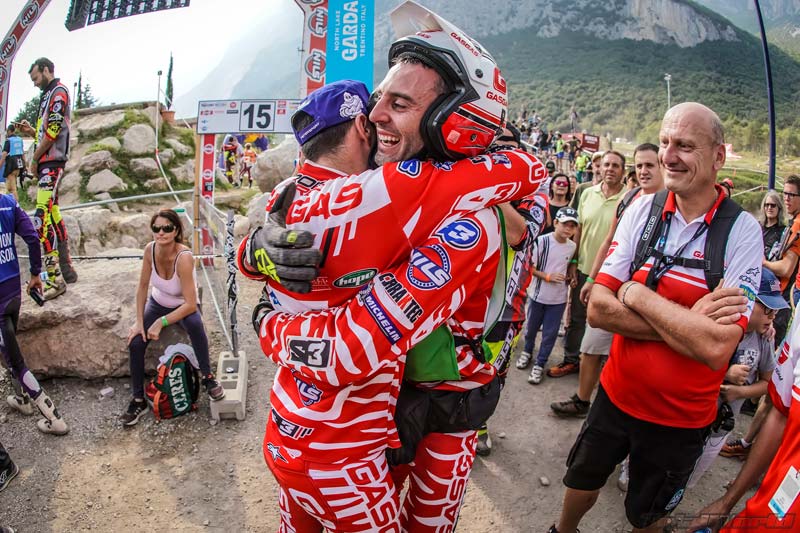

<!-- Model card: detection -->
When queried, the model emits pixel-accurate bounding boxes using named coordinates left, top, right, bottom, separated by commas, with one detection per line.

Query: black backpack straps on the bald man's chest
left=631, top=190, right=742, bottom=291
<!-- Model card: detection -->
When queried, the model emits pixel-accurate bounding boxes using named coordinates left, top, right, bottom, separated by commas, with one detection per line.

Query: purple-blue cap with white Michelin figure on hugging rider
left=292, top=80, right=369, bottom=146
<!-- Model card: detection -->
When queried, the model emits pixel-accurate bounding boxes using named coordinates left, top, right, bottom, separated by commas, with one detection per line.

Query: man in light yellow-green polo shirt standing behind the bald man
left=547, top=150, right=626, bottom=380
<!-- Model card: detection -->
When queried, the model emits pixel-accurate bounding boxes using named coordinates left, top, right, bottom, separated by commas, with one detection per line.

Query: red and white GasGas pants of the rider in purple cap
left=264, top=443, right=400, bottom=533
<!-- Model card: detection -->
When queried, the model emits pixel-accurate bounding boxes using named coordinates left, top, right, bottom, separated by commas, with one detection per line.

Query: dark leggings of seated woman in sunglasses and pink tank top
left=128, top=298, right=211, bottom=399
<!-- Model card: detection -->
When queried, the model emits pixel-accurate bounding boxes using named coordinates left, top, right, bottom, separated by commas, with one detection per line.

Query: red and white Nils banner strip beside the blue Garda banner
left=295, top=0, right=329, bottom=96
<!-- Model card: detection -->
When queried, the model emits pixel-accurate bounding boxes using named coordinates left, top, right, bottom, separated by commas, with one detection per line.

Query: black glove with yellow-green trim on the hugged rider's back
left=245, top=182, right=322, bottom=294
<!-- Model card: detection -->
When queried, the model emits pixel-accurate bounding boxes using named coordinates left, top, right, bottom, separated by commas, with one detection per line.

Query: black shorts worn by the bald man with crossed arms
left=564, top=386, right=709, bottom=528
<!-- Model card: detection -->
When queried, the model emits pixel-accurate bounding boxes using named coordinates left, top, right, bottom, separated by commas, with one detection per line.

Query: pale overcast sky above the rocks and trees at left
left=0, top=0, right=302, bottom=118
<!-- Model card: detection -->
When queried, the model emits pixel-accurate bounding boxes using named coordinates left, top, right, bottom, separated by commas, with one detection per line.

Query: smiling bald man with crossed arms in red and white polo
left=550, top=103, right=763, bottom=533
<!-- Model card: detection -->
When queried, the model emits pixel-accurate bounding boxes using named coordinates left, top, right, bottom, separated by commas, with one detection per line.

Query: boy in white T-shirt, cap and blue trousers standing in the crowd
left=517, top=206, right=578, bottom=385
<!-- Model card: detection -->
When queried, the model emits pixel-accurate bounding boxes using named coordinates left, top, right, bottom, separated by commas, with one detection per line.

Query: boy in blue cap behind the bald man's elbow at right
left=688, top=268, right=789, bottom=487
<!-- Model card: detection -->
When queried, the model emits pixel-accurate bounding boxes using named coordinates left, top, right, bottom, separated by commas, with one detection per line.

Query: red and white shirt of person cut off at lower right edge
left=722, top=317, right=800, bottom=533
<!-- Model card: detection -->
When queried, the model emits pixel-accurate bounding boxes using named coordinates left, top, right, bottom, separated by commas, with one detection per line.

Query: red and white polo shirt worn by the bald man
left=596, top=187, right=764, bottom=428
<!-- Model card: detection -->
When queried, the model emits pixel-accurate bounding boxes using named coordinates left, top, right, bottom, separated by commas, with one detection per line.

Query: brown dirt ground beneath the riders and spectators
left=0, top=277, right=750, bottom=533
